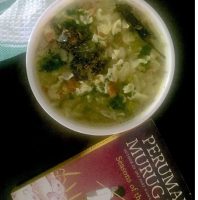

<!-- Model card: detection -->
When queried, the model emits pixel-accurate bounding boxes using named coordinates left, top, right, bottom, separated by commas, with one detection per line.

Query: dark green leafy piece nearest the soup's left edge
left=40, top=51, right=65, bottom=72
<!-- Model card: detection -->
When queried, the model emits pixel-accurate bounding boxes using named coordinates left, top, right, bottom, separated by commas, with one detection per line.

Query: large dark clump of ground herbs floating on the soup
left=58, top=20, right=106, bottom=80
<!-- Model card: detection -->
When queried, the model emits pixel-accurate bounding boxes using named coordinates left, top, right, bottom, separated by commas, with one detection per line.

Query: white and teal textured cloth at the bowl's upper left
left=0, top=0, right=55, bottom=61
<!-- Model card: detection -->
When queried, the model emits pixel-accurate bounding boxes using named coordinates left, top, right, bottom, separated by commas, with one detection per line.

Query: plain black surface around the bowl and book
left=0, top=0, right=195, bottom=200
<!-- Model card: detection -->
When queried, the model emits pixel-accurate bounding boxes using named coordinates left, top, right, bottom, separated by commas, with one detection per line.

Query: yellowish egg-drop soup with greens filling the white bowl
left=36, top=0, right=166, bottom=125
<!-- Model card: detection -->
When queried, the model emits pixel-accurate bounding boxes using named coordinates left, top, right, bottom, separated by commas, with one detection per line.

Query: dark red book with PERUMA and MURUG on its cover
left=11, top=121, right=191, bottom=200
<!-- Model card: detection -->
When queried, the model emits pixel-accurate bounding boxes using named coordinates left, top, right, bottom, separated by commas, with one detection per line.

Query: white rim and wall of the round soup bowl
left=26, top=0, right=175, bottom=135
